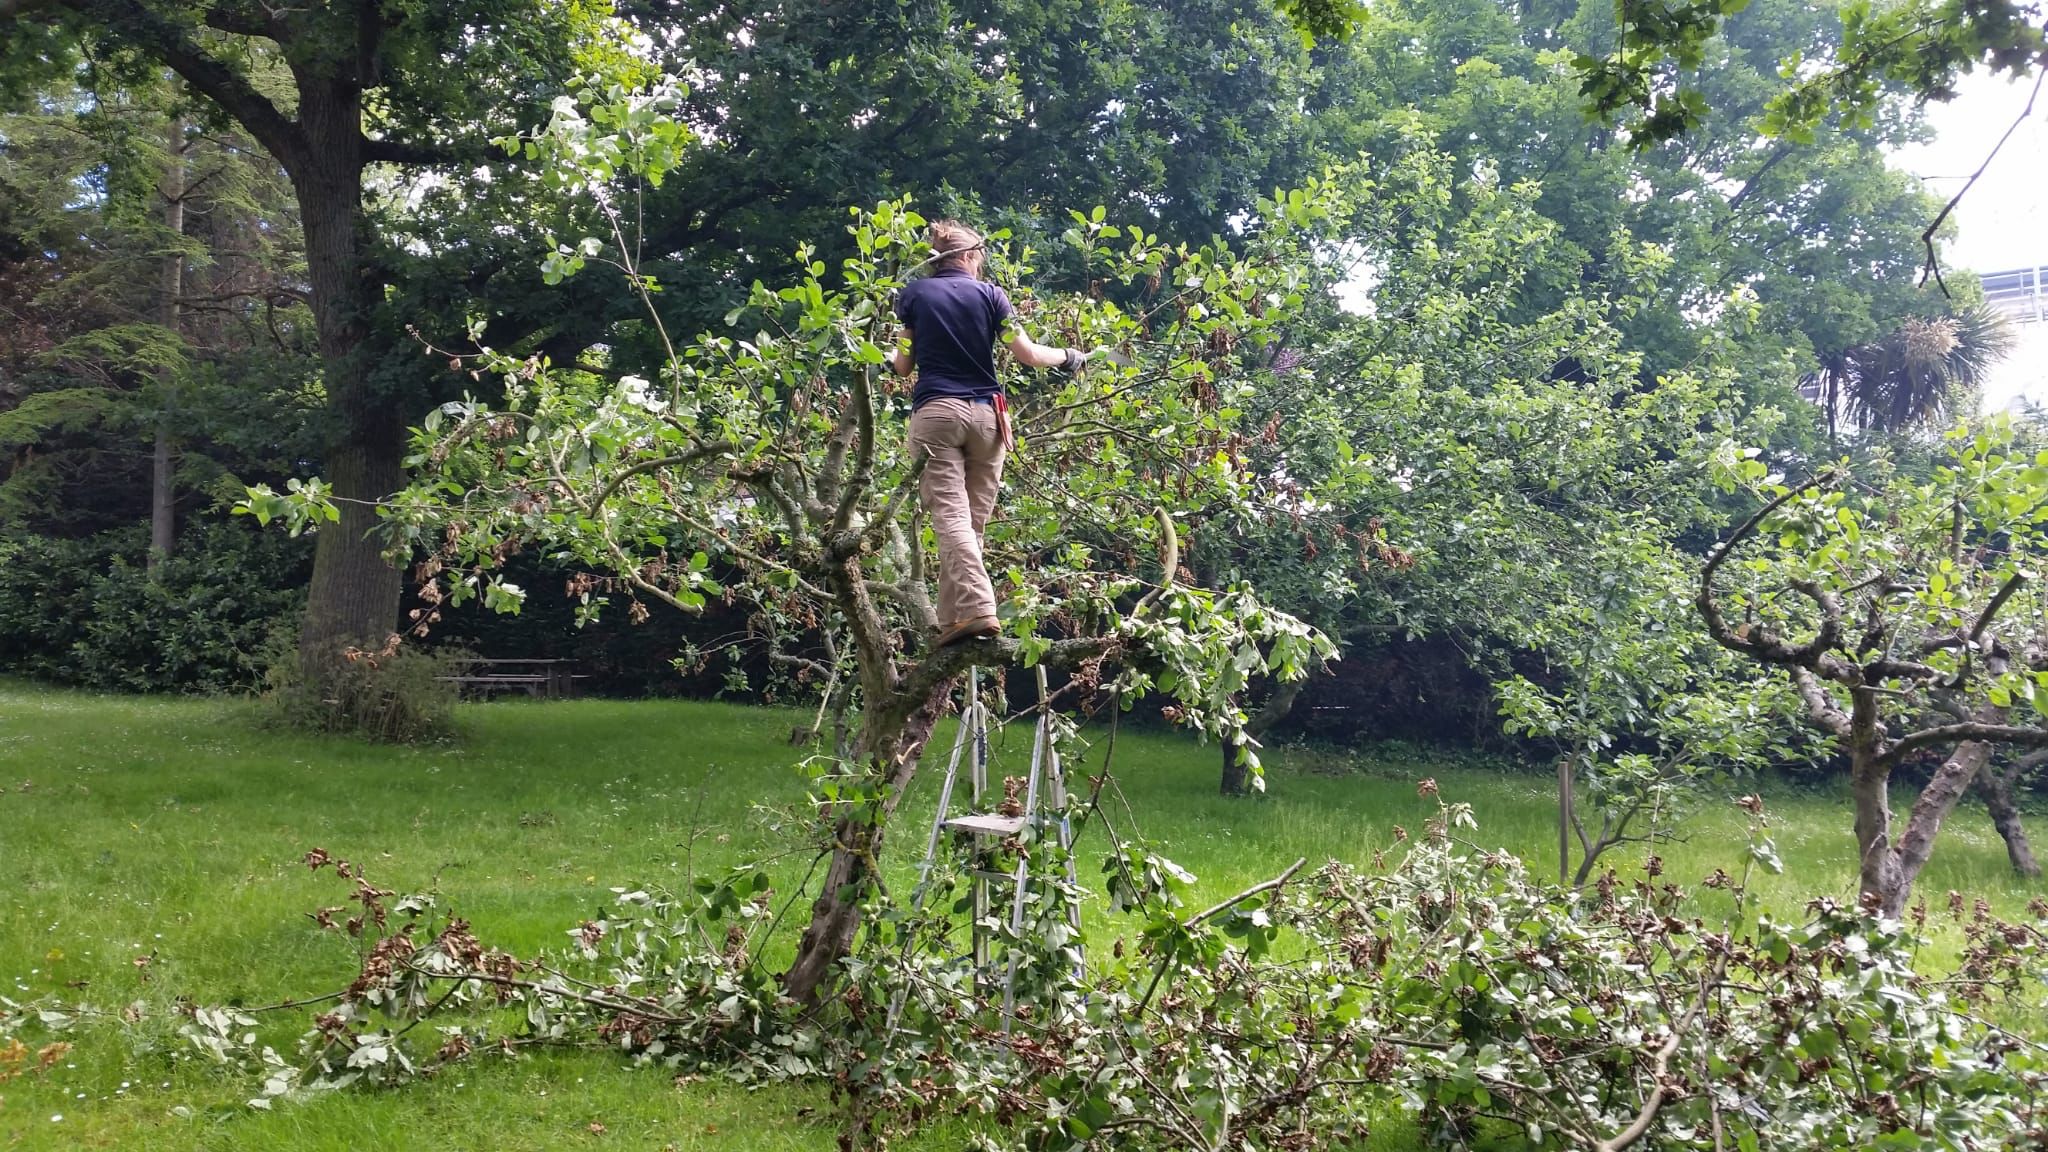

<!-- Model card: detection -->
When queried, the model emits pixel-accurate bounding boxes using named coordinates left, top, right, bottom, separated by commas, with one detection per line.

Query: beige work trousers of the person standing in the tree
left=909, top=398, right=1004, bottom=627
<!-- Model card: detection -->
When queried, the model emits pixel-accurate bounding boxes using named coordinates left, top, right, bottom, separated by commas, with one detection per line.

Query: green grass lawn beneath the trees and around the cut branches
left=0, top=683, right=2044, bottom=1152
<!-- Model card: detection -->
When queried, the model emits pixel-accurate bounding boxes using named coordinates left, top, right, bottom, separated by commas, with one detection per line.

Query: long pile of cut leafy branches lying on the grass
left=19, top=781, right=2048, bottom=1150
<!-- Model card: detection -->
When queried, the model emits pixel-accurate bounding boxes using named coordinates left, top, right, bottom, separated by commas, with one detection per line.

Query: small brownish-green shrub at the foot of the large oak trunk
left=264, top=640, right=463, bottom=744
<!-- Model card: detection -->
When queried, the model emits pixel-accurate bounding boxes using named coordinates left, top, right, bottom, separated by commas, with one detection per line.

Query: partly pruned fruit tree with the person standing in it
left=246, top=86, right=1333, bottom=1000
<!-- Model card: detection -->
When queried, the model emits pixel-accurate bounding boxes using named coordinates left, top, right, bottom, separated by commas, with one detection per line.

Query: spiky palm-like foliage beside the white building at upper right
left=1804, top=303, right=2013, bottom=435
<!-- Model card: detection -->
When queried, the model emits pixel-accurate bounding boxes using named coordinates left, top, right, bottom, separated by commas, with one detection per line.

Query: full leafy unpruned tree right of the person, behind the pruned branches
left=1190, top=139, right=1788, bottom=803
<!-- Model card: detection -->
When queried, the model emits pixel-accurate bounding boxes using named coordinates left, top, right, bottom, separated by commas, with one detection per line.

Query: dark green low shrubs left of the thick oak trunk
left=0, top=523, right=309, bottom=693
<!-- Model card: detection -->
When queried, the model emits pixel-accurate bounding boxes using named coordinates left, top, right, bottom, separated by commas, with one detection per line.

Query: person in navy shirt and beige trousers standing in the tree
left=889, top=219, right=1085, bottom=648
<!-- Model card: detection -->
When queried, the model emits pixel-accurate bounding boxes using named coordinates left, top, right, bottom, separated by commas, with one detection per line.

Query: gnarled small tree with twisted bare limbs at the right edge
left=1698, top=418, right=2048, bottom=916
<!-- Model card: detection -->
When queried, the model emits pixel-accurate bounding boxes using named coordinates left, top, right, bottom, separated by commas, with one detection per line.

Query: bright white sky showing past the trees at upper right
left=1892, top=74, right=2048, bottom=410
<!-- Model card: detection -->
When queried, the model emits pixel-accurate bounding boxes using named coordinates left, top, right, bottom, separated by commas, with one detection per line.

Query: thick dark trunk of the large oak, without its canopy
left=291, top=76, right=406, bottom=681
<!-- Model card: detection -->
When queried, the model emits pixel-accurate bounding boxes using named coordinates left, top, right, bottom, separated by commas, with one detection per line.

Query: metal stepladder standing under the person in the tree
left=889, top=668, right=1083, bottom=1029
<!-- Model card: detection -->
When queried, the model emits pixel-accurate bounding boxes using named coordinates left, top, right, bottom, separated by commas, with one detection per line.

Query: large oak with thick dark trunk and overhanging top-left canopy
left=0, top=0, right=590, bottom=670
